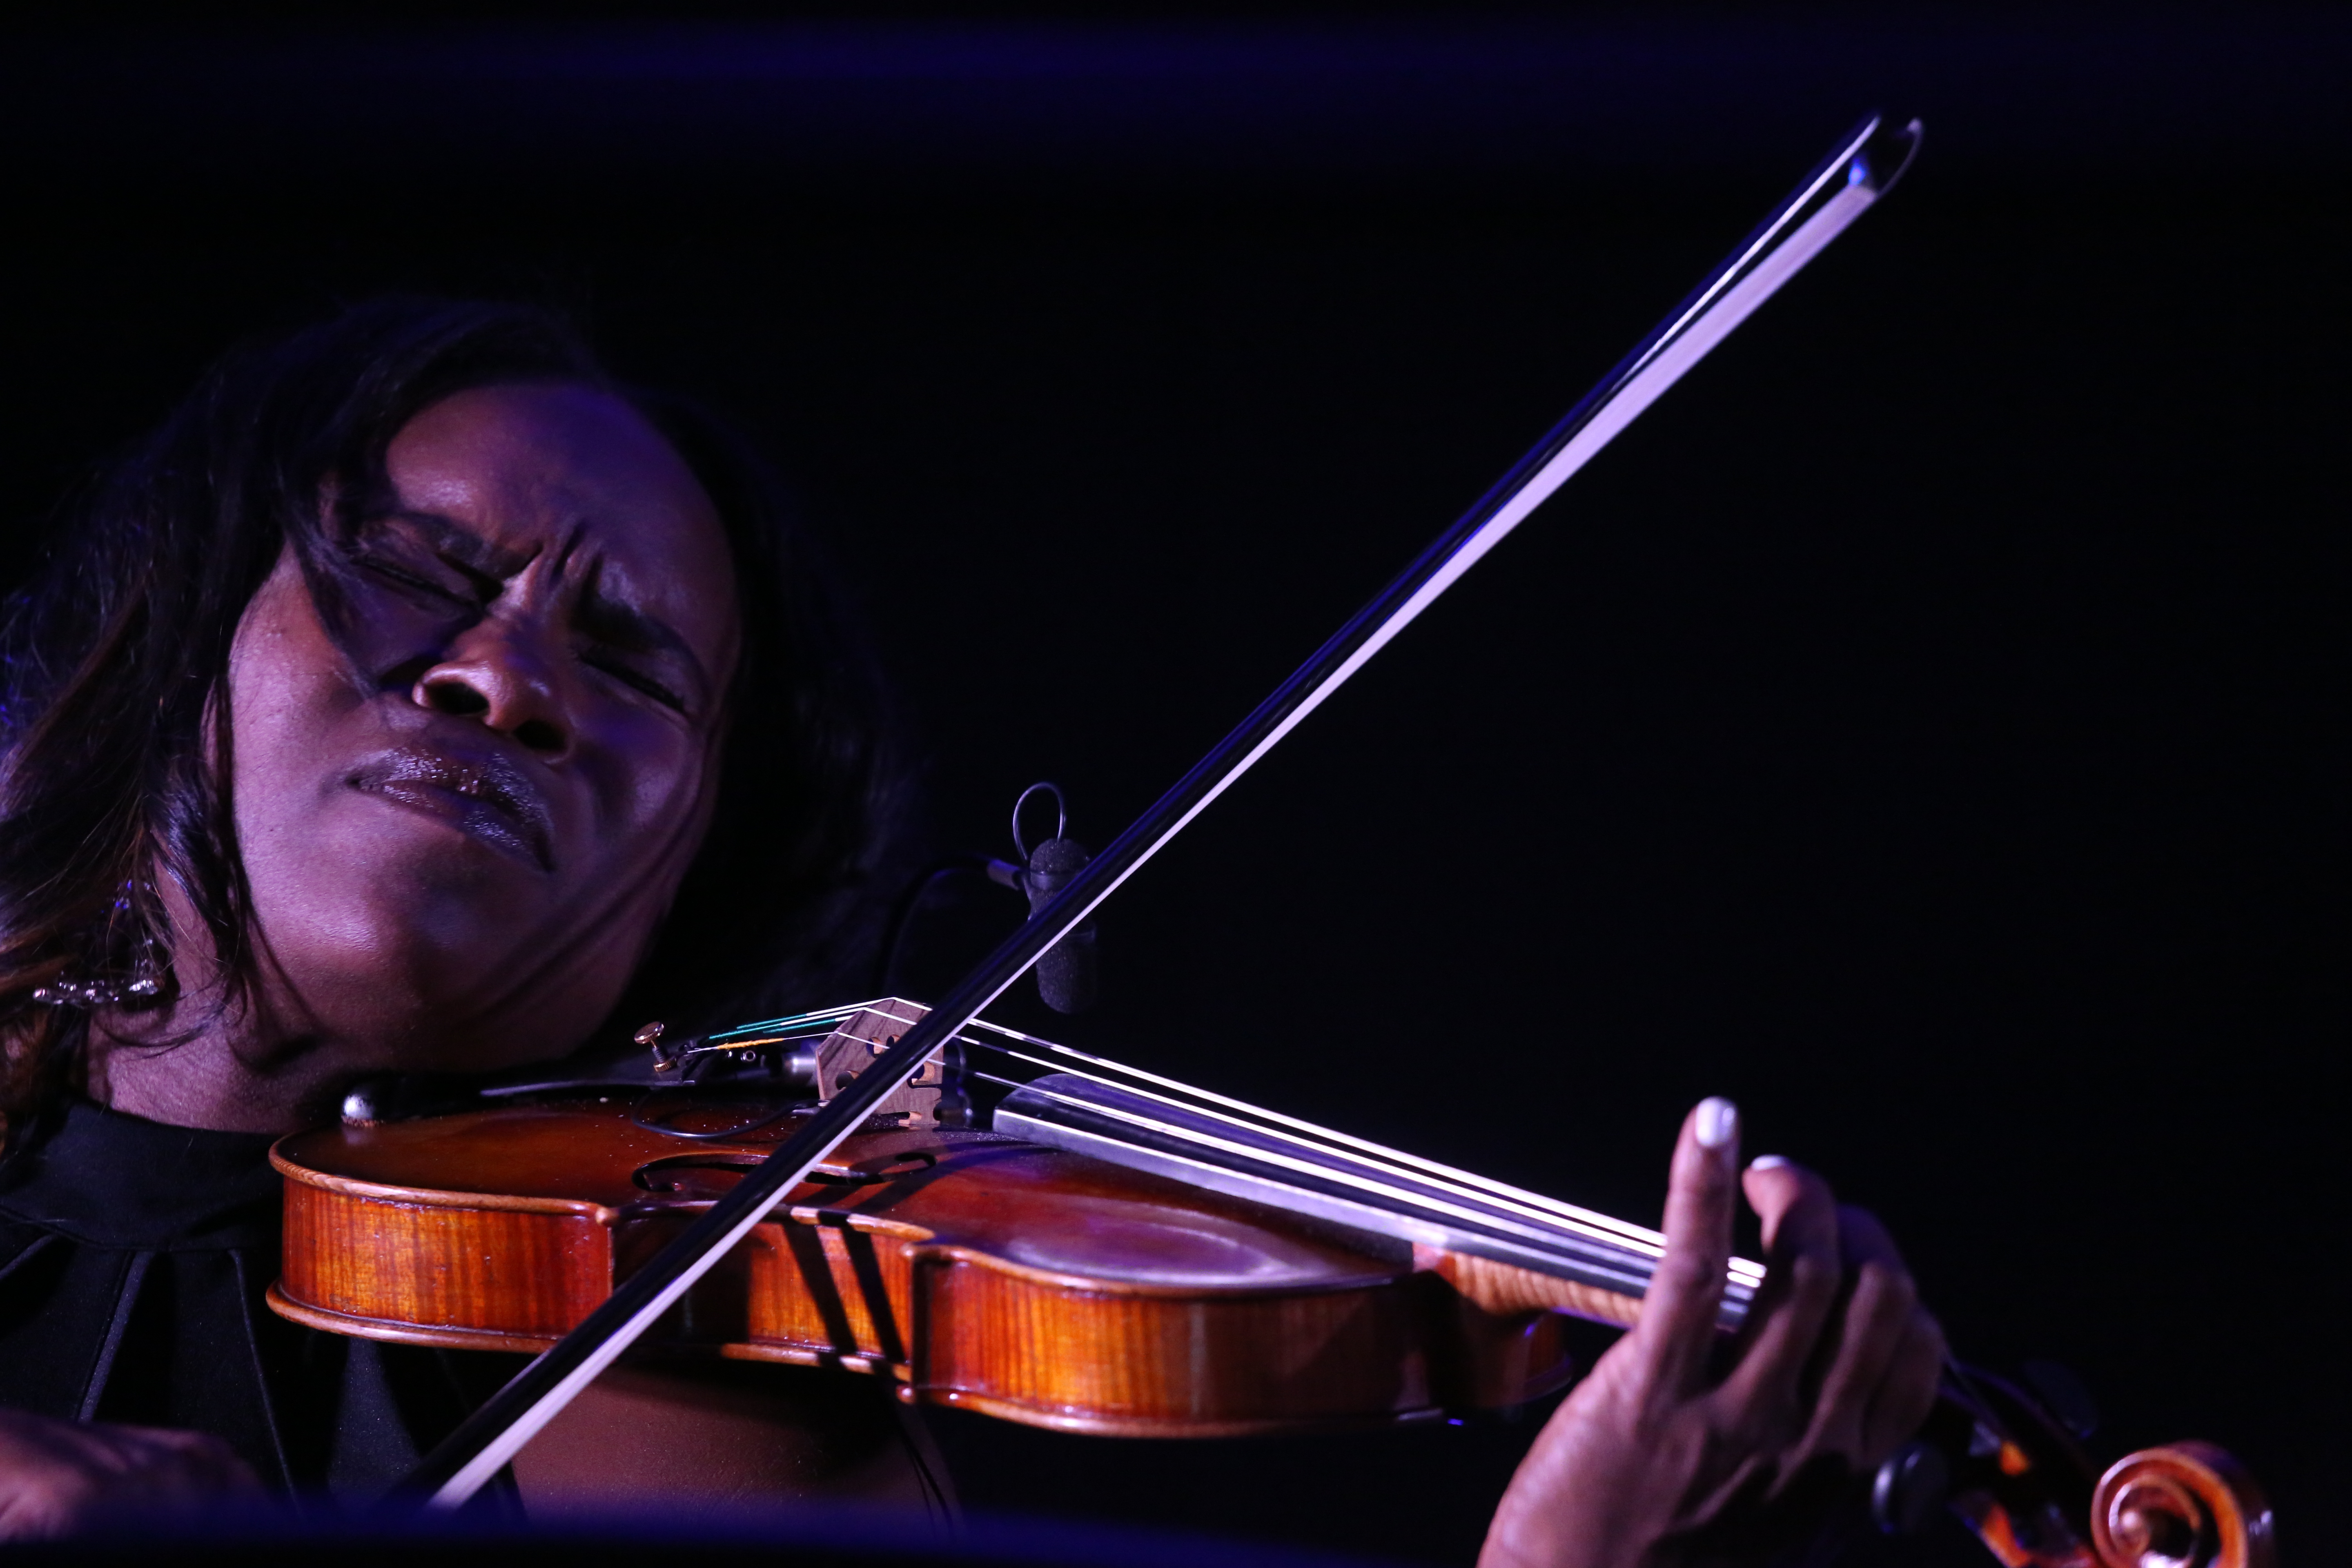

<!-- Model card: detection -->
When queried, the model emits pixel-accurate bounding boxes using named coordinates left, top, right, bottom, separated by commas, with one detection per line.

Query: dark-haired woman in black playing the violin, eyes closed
left=0, top=301, right=1943, bottom=1566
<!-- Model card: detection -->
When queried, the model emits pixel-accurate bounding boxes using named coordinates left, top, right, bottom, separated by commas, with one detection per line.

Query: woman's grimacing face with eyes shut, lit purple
left=228, top=385, right=739, bottom=1072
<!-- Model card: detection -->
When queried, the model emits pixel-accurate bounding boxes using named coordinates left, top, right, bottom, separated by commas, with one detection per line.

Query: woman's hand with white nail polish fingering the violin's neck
left=1479, top=1100, right=1943, bottom=1568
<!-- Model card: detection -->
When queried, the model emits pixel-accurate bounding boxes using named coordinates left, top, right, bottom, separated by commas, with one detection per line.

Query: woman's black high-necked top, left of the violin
left=0, top=1100, right=522, bottom=1495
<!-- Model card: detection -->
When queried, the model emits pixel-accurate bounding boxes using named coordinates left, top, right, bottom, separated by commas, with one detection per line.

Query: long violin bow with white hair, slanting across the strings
left=397, top=115, right=1919, bottom=1509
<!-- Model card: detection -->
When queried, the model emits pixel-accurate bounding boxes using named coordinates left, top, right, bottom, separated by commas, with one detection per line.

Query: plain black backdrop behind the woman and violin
left=0, top=7, right=2352, bottom=1559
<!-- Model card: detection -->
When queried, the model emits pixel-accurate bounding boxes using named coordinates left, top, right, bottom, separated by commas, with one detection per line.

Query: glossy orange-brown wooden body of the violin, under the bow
left=270, top=1098, right=1571, bottom=1437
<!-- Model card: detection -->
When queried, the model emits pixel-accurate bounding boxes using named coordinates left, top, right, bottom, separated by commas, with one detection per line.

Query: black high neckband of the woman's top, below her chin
left=0, top=1098, right=282, bottom=1253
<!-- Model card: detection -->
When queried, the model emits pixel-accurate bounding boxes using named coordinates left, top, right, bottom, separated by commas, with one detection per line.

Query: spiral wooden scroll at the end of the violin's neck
left=2091, top=1443, right=2279, bottom=1568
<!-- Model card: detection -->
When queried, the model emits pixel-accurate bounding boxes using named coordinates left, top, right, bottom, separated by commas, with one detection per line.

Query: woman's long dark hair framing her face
left=0, top=298, right=906, bottom=1143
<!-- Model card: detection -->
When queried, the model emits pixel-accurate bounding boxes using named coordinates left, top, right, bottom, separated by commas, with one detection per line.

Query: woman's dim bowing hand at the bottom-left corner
left=0, top=1410, right=261, bottom=1540
